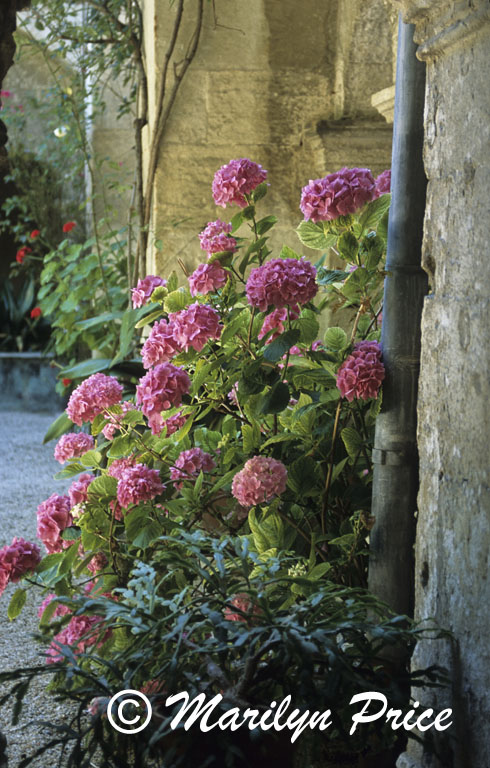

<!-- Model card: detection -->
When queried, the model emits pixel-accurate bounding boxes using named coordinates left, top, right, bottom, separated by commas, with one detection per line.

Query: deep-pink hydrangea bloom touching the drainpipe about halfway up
left=337, top=341, right=385, bottom=402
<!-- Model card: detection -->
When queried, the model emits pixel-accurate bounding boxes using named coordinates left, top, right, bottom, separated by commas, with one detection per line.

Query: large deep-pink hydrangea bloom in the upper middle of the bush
left=246, top=258, right=318, bottom=312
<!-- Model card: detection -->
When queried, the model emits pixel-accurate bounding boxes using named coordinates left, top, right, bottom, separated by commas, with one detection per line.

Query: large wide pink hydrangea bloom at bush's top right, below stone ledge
left=299, top=168, right=376, bottom=222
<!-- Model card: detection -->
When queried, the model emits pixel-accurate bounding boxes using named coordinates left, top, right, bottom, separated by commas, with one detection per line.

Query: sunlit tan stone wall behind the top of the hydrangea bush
left=144, top=0, right=396, bottom=274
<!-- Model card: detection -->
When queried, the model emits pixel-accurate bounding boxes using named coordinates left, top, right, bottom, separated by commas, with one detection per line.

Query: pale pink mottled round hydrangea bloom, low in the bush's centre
left=231, top=456, right=288, bottom=507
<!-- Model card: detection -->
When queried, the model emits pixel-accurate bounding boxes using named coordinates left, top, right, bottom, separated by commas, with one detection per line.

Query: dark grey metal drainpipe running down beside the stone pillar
left=369, top=16, right=427, bottom=615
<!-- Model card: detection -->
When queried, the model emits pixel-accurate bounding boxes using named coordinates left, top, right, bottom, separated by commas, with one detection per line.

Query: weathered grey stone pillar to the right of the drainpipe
left=395, top=0, right=490, bottom=768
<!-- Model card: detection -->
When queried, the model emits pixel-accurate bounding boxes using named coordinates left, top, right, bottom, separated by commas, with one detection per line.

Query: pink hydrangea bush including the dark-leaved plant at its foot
left=0, top=159, right=444, bottom=766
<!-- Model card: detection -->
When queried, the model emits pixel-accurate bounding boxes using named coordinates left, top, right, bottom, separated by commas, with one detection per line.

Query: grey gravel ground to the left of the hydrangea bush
left=0, top=403, right=73, bottom=768
